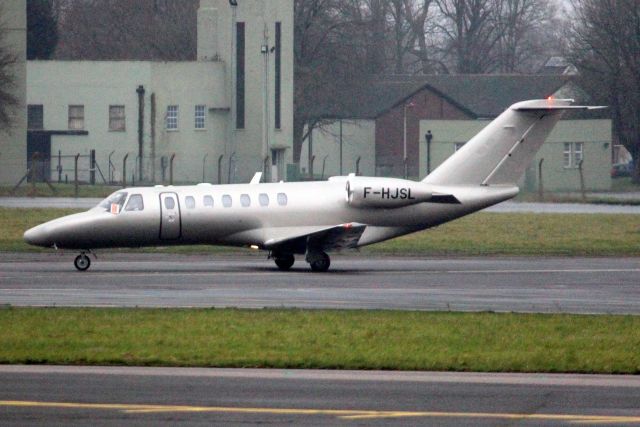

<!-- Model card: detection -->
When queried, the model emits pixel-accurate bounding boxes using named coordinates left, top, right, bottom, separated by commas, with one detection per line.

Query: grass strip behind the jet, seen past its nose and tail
left=0, top=208, right=640, bottom=256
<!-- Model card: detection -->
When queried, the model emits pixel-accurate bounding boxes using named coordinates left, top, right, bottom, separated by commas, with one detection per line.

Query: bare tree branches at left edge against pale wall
left=0, top=12, right=19, bottom=129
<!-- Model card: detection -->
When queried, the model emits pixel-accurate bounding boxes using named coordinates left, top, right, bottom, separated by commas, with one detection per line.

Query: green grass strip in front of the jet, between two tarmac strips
left=0, top=308, right=640, bottom=374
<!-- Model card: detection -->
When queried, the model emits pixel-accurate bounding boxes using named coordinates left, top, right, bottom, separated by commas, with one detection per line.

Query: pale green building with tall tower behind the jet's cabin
left=27, top=0, right=293, bottom=183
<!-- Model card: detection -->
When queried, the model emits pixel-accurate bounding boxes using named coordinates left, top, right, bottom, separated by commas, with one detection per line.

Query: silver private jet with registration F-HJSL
left=24, top=98, right=602, bottom=271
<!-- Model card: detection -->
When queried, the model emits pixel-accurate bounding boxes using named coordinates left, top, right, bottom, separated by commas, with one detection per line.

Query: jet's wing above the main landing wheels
left=264, top=223, right=367, bottom=253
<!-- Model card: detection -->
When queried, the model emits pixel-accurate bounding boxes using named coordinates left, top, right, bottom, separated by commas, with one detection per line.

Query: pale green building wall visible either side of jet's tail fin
left=420, top=119, right=611, bottom=191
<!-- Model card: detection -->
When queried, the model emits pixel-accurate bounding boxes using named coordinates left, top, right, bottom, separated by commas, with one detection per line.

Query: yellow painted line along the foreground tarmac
left=0, top=400, right=640, bottom=424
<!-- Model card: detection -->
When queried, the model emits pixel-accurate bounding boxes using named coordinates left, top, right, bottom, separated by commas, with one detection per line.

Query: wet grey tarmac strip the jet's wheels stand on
left=0, top=252, right=640, bottom=314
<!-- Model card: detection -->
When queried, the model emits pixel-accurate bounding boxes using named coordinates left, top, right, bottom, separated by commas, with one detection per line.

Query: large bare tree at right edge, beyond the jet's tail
left=570, top=0, right=640, bottom=182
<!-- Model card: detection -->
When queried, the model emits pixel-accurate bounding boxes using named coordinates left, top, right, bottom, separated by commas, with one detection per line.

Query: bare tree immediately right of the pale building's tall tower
left=293, top=0, right=378, bottom=163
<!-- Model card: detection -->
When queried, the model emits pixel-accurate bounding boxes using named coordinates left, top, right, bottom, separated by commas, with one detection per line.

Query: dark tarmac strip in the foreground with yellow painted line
left=0, top=366, right=640, bottom=426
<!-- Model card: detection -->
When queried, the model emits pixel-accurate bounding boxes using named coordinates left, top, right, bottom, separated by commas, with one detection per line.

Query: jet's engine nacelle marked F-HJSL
left=346, top=177, right=432, bottom=209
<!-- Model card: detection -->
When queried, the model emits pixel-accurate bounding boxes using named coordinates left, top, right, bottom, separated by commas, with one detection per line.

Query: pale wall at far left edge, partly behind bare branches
left=0, top=0, right=27, bottom=184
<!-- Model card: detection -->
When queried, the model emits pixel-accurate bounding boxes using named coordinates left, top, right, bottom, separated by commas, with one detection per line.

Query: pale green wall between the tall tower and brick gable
left=300, top=120, right=376, bottom=179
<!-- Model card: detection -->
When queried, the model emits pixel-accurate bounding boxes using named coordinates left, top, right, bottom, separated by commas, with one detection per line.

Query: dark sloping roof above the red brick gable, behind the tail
left=336, top=74, right=570, bottom=119
